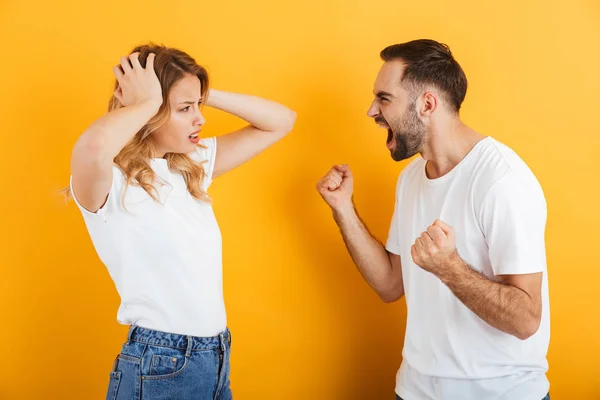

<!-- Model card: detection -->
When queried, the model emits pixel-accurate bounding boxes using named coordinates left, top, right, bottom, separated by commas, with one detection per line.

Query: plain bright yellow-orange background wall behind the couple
left=0, top=0, right=600, bottom=400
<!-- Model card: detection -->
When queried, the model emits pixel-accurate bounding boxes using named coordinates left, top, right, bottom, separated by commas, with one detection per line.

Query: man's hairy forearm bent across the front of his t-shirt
left=437, top=254, right=540, bottom=340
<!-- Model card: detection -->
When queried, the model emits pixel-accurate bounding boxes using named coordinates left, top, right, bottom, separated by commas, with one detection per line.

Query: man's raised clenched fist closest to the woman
left=317, top=165, right=354, bottom=211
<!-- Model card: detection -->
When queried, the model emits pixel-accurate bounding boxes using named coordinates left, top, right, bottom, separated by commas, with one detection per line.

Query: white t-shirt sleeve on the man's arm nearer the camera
left=480, top=172, right=547, bottom=275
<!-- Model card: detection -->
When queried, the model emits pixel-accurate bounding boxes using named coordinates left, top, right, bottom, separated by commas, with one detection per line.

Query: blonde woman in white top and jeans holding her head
left=70, top=45, right=295, bottom=400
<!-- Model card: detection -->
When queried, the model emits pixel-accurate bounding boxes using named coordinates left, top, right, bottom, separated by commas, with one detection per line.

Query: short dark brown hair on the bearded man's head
left=380, top=39, right=467, bottom=113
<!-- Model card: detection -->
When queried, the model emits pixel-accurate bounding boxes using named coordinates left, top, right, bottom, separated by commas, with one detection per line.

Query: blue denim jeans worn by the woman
left=106, top=326, right=232, bottom=400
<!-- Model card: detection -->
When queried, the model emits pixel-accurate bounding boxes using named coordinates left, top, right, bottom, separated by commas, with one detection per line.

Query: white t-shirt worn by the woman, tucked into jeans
left=71, top=137, right=226, bottom=337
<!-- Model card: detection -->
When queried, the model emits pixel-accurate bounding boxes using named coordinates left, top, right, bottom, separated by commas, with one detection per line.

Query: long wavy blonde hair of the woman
left=67, top=43, right=209, bottom=202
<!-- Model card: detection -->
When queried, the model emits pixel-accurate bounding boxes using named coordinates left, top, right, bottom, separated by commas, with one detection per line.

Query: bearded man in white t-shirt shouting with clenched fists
left=317, top=40, right=550, bottom=400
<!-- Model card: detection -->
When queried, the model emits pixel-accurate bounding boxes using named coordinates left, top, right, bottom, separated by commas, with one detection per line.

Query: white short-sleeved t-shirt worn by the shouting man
left=386, top=137, right=550, bottom=400
